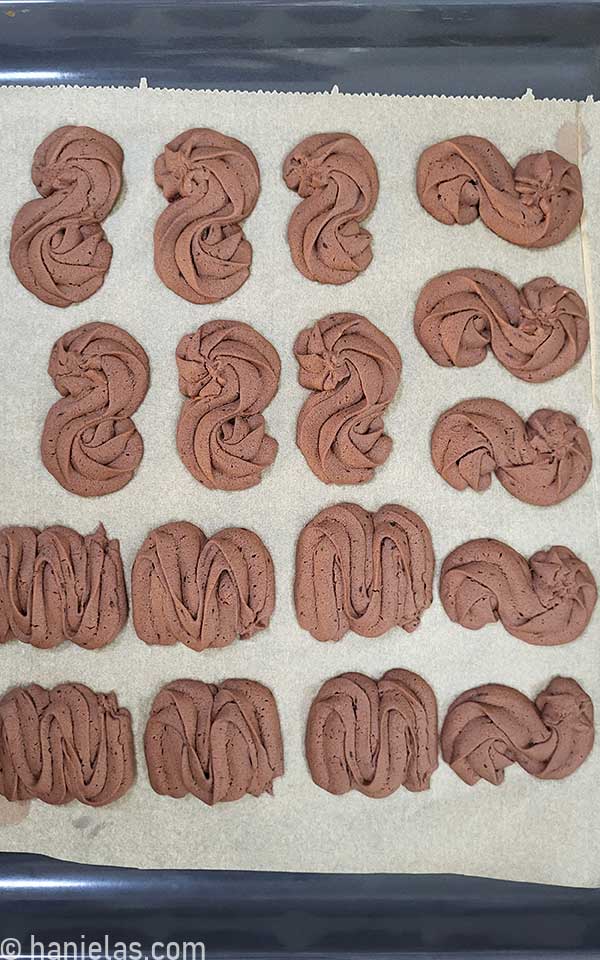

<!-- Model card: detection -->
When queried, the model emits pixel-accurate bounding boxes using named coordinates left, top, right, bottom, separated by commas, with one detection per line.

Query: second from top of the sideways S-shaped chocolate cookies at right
left=414, top=269, right=589, bottom=383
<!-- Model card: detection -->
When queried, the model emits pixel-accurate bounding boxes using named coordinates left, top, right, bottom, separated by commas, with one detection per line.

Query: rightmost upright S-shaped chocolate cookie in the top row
left=283, top=133, right=379, bottom=283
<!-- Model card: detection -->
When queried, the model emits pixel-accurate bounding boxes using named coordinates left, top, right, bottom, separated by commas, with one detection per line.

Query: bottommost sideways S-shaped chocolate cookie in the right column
left=441, top=677, right=594, bottom=786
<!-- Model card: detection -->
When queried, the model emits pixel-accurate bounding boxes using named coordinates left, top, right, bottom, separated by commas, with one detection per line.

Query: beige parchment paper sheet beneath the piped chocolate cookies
left=0, top=88, right=600, bottom=886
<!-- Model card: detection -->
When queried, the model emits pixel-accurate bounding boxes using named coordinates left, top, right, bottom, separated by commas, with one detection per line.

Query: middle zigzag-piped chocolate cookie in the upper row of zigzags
left=131, top=523, right=275, bottom=650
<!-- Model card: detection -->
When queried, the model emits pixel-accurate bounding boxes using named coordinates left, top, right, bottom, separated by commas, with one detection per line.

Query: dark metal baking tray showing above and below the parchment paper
left=0, top=0, right=600, bottom=960
